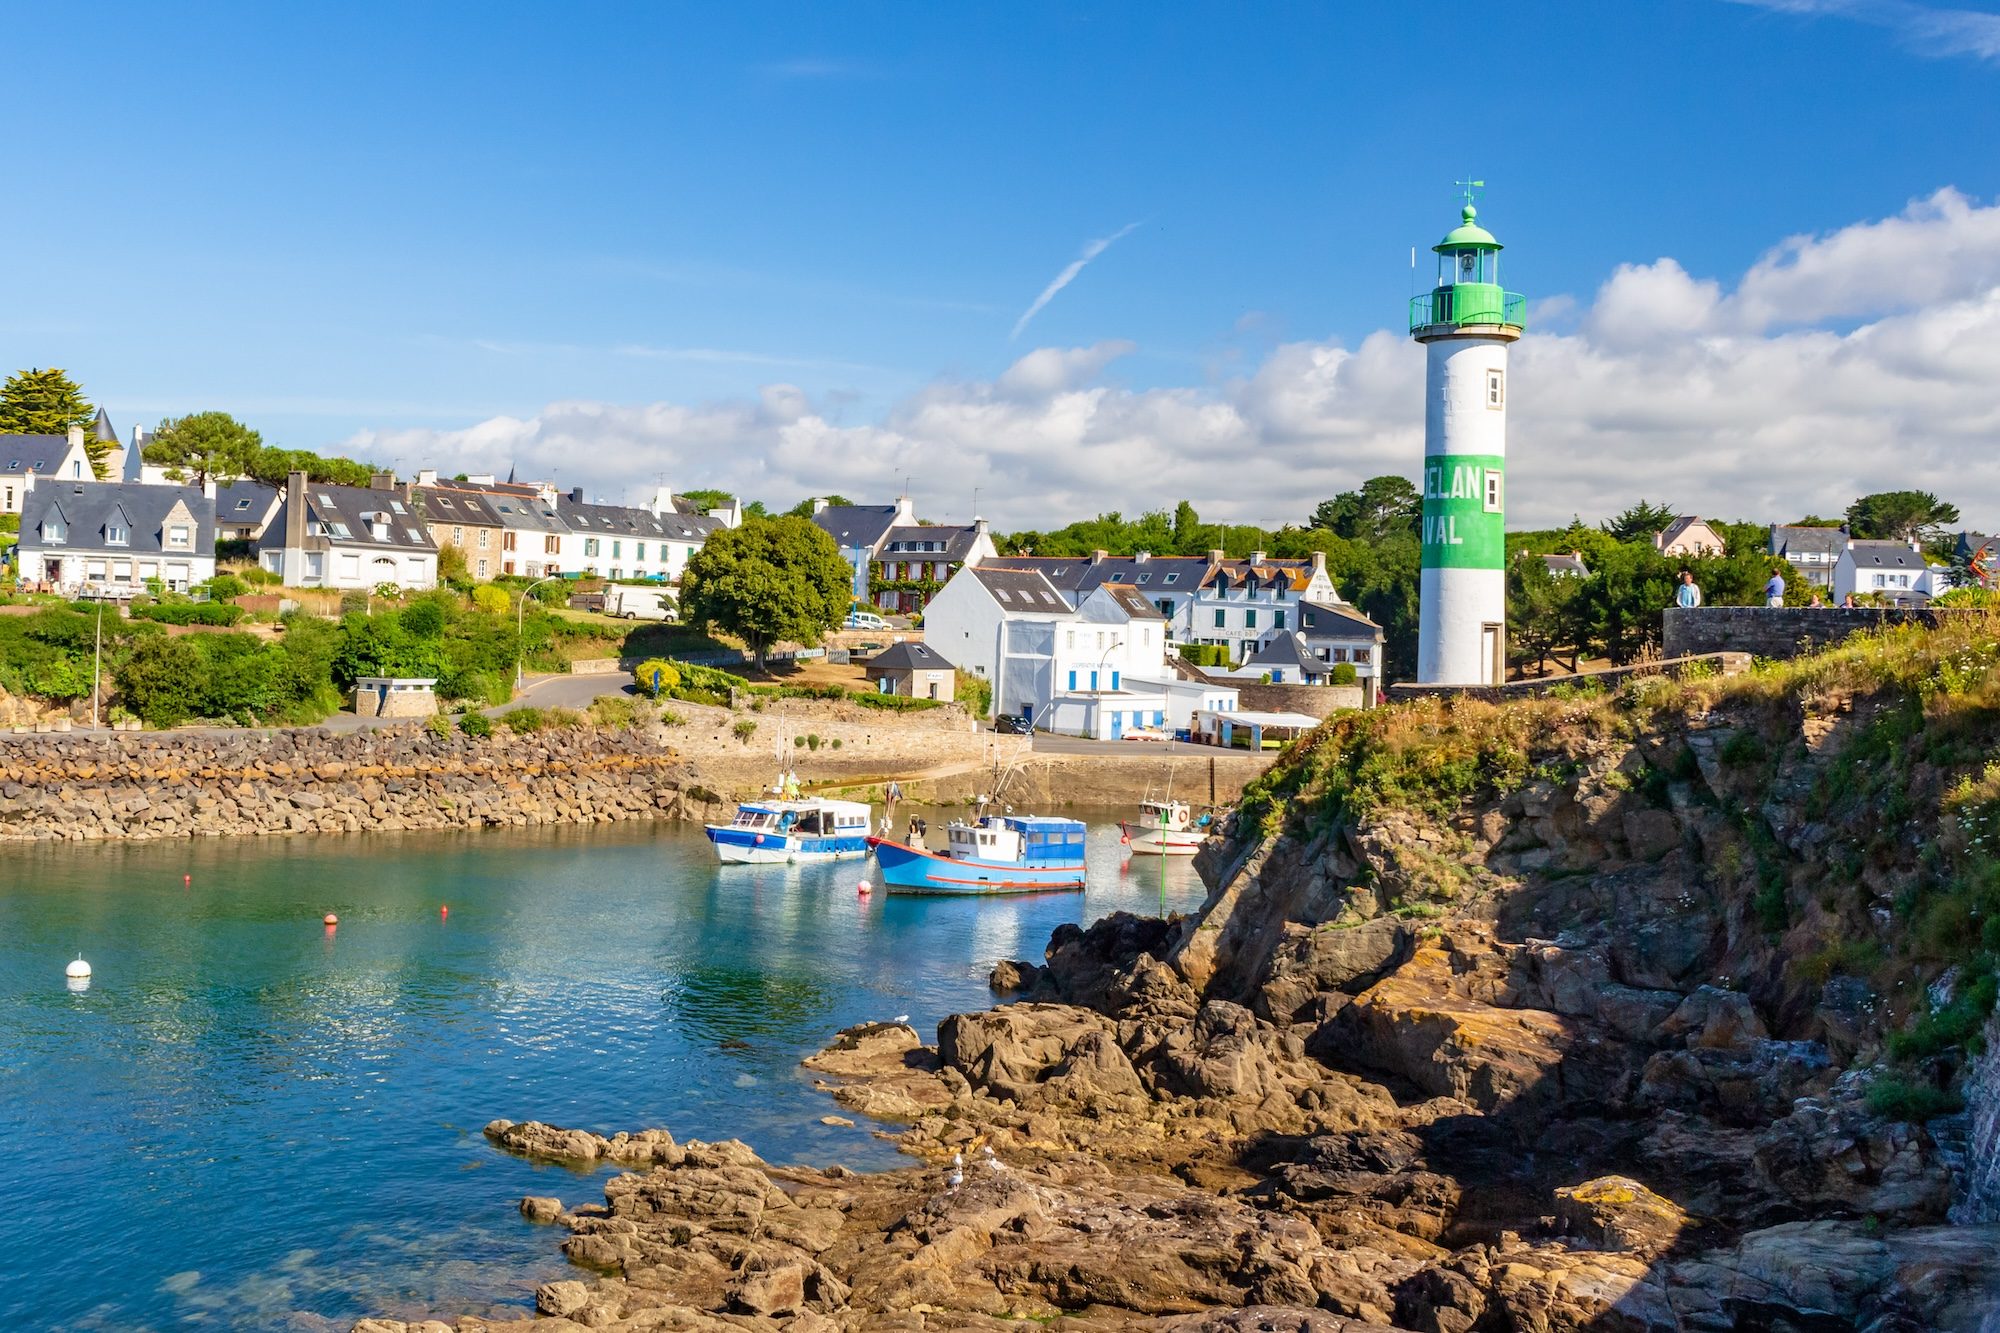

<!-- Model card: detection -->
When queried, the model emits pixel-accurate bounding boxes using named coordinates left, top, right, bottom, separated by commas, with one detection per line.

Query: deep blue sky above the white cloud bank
left=0, top=0, right=2000, bottom=520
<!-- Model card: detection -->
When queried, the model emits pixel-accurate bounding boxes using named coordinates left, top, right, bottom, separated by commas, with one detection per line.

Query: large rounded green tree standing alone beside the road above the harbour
left=680, top=514, right=852, bottom=671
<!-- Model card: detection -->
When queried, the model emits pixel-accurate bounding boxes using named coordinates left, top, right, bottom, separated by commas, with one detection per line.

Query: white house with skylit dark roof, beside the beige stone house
left=258, top=472, right=438, bottom=588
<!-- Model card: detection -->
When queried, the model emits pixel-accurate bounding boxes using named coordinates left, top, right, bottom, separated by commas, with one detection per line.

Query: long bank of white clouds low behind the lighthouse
left=348, top=190, right=2000, bottom=528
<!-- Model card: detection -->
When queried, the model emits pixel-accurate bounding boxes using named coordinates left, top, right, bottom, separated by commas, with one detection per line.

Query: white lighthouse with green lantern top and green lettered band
left=1410, top=180, right=1524, bottom=685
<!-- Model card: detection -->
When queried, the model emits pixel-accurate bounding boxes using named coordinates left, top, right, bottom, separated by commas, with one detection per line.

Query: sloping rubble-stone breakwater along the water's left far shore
left=0, top=727, right=682, bottom=843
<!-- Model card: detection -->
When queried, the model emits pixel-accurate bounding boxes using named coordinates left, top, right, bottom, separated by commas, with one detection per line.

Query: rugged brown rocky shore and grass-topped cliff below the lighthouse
left=362, top=636, right=2000, bottom=1333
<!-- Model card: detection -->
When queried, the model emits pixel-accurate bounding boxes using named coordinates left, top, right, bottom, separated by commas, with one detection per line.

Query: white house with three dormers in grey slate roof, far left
left=20, top=478, right=216, bottom=596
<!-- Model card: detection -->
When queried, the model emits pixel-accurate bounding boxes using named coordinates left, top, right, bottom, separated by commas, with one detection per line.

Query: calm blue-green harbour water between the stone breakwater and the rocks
left=0, top=808, right=1202, bottom=1333
